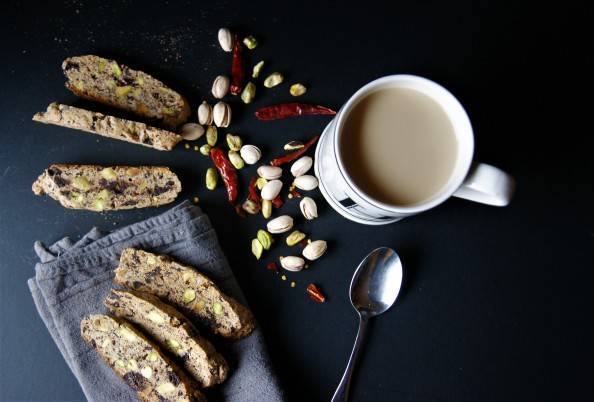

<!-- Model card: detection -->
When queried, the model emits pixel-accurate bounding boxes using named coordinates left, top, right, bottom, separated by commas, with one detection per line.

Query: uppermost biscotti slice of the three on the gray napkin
left=114, top=248, right=255, bottom=339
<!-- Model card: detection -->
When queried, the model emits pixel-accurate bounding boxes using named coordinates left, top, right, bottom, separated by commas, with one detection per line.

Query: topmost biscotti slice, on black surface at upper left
left=62, top=55, right=190, bottom=128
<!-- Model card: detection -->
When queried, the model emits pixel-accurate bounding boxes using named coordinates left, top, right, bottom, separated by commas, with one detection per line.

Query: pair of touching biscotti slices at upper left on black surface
left=33, top=55, right=190, bottom=151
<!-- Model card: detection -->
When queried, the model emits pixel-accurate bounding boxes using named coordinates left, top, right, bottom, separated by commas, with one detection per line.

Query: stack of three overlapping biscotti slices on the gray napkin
left=81, top=248, right=255, bottom=401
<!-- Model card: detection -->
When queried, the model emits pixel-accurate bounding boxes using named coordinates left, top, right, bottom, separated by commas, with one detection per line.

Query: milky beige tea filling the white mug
left=339, top=87, right=458, bottom=206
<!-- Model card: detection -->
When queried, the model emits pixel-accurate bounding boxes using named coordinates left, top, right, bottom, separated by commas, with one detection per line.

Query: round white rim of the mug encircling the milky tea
left=333, top=74, right=474, bottom=214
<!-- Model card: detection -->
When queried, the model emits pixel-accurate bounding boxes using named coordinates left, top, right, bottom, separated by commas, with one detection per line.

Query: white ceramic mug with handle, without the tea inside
left=314, top=75, right=514, bottom=225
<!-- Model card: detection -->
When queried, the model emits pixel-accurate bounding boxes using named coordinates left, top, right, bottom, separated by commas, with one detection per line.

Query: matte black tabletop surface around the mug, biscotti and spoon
left=0, top=1, right=594, bottom=401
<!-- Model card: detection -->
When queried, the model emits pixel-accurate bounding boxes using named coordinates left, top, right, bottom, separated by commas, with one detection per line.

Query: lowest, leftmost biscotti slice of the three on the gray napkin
left=80, top=314, right=206, bottom=402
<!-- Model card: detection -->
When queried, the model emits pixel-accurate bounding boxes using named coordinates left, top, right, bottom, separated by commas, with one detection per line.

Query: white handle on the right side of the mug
left=453, top=163, right=516, bottom=207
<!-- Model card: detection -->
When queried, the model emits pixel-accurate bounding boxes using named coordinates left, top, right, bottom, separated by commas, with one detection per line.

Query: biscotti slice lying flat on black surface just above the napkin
left=33, top=165, right=181, bottom=212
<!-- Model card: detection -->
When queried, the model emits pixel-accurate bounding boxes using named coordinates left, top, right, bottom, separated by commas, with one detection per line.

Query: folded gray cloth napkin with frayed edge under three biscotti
left=28, top=201, right=283, bottom=402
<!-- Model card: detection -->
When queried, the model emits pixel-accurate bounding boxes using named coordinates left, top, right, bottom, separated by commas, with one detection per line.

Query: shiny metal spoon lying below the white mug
left=332, top=247, right=402, bottom=402
